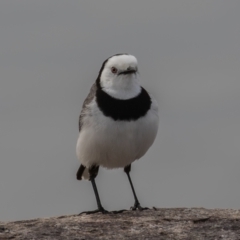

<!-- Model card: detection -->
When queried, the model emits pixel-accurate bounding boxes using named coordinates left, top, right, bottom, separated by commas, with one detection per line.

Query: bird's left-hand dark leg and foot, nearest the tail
left=80, top=166, right=108, bottom=214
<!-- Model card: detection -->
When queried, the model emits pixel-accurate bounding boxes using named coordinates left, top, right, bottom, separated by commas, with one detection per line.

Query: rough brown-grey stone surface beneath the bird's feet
left=0, top=208, right=240, bottom=240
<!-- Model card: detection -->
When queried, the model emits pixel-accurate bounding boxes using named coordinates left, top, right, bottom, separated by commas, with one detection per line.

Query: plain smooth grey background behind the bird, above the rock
left=0, top=0, right=240, bottom=220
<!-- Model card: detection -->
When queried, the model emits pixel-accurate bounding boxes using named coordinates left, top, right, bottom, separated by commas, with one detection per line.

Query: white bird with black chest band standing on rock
left=76, top=53, right=159, bottom=214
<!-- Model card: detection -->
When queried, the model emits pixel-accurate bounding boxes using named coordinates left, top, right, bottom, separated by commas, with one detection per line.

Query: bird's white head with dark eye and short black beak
left=99, top=54, right=141, bottom=99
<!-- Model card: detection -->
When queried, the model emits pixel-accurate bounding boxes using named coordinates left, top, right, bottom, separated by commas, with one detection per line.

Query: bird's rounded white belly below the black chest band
left=76, top=99, right=158, bottom=168
